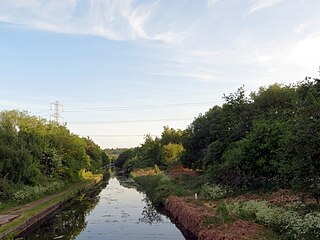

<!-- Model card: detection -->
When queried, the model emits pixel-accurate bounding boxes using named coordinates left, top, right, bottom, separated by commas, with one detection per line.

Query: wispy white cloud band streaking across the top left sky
left=0, top=0, right=184, bottom=42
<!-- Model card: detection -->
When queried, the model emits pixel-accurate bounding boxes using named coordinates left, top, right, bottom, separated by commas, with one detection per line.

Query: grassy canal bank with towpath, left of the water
left=0, top=175, right=104, bottom=239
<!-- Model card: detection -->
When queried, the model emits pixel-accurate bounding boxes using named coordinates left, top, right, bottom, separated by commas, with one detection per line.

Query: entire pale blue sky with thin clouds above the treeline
left=0, top=0, right=320, bottom=148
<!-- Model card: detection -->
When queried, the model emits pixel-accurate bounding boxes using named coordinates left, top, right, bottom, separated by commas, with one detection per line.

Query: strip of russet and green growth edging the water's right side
left=131, top=170, right=279, bottom=240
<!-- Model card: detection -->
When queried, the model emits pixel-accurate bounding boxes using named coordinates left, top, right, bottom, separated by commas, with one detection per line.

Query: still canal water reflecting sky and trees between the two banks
left=21, top=176, right=194, bottom=240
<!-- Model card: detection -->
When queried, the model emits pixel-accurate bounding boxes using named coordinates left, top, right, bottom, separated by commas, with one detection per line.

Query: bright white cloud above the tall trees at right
left=172, top=28, right=320, bottom=86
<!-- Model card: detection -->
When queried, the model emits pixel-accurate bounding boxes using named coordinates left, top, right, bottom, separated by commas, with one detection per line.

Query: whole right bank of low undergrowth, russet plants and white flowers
left=132, top=169, right=320, bottom=240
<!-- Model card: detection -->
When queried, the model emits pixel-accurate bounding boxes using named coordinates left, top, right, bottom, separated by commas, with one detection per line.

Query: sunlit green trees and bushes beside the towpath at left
left=0, top=111, right=110, bottom=202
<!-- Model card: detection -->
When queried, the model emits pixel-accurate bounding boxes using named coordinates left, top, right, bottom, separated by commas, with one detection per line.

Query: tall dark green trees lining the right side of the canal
left=116, top=78, right=320, bottom=202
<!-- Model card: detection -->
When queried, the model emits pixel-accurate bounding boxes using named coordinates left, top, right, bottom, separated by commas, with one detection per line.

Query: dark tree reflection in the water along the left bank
left=22, top=182, right=107, bottom=239
